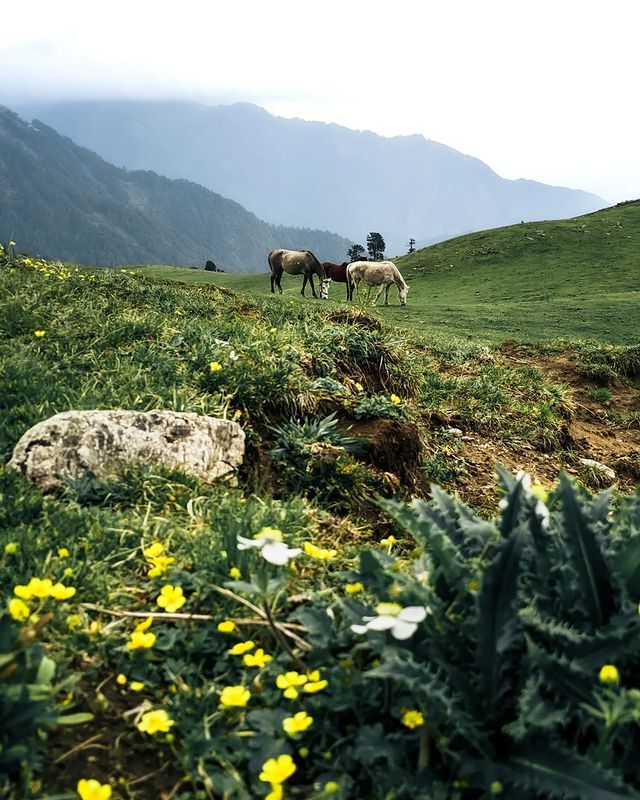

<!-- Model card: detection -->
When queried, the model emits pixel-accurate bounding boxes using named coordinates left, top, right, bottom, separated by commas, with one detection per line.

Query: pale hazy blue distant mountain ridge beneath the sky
left=15, top=101, right=607, bottom=255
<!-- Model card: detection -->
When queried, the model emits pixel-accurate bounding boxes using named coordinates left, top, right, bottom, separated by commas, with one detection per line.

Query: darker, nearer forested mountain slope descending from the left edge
left=0, top=106, right=350, bottom=272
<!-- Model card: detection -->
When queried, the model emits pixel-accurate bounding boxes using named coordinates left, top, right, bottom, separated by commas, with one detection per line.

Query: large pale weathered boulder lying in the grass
left=9, top=410, right=244, bottom=491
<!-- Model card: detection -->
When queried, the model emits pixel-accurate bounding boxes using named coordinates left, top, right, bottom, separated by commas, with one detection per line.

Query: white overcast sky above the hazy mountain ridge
left=0, top=0, right=640, bottom=202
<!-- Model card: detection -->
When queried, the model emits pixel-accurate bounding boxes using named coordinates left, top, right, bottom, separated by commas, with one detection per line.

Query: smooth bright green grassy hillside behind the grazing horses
left=136, top=201, right=640, bottom=344
